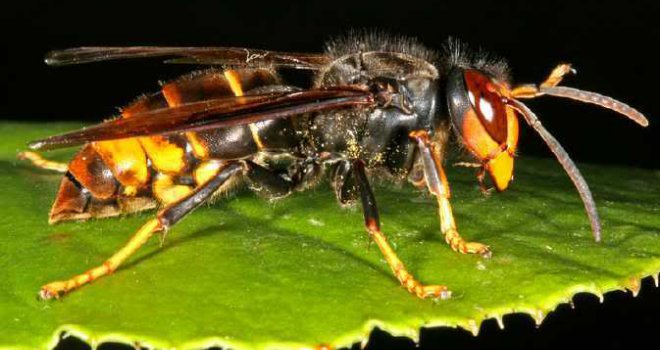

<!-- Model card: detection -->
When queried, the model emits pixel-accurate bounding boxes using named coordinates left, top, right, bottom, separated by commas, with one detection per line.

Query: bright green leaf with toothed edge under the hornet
left=0, top=122, right=660, bottom=349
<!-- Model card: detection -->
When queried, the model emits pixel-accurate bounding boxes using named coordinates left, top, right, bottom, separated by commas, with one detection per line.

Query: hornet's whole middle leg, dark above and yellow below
left=353, top=160, right=451, bottom=299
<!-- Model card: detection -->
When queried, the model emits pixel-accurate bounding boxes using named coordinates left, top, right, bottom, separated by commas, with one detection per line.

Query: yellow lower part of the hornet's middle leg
left=367, top=221, right=451, bottom=299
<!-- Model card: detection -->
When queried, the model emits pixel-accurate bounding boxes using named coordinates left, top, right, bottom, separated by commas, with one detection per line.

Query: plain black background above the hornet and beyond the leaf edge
left=0, top=0, right=660, bottom=349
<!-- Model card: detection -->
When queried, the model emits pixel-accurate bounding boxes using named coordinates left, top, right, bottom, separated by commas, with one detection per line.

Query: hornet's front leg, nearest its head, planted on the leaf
left=410, top=130, right=491, bottom=257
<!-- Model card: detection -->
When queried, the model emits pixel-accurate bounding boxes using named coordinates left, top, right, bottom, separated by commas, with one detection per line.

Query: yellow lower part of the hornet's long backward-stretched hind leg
left=39, top=219, right=162, bottom=299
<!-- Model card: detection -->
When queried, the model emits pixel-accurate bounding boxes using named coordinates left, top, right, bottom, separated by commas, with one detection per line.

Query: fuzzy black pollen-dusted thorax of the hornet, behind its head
left=307, top=51, right=438, bottom=176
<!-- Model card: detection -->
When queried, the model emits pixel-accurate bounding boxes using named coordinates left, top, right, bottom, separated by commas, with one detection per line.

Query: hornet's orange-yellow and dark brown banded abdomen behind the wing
left=50, top=69, right=300, bottom=223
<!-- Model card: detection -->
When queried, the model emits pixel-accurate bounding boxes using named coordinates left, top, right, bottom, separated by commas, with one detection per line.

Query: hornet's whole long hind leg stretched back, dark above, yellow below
left=39, top=162, right=245, bottom=299
